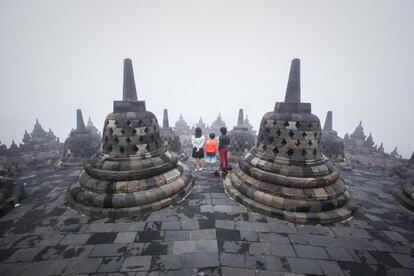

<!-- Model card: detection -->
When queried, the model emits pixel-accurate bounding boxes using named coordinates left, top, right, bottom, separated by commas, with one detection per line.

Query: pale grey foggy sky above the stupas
left=0, top=0, right=414, bottom=158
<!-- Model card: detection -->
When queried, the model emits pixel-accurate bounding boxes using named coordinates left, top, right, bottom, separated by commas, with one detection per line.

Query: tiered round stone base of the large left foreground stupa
left=67, top=164, right=193, bottom=217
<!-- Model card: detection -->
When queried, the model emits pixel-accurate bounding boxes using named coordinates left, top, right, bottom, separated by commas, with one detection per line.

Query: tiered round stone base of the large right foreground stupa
left=224, top=155, right=358, bottom=224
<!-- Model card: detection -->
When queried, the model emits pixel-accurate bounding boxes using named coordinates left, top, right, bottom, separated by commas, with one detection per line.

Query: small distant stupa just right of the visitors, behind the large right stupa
left=229, top=109, right=255, bottom=161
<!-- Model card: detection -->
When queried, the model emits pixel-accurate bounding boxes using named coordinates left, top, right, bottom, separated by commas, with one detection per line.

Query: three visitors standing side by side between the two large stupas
left=191, top=127, right=230, bottom=172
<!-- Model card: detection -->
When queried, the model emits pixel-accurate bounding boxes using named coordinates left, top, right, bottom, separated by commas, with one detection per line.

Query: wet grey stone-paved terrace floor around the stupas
left=0, top=161, right=414, bottom=276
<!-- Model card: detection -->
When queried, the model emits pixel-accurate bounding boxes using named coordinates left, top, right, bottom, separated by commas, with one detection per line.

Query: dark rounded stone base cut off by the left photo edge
left=0, top=179, right=24, bottom=217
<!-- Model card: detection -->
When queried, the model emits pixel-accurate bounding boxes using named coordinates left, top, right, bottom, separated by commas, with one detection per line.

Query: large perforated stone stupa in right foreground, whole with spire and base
left=224, top=59, right=357, bottom=224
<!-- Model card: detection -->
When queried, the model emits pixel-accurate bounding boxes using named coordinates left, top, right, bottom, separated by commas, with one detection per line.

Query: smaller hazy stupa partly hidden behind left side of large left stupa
left=57, top=109, right=100, bottom=168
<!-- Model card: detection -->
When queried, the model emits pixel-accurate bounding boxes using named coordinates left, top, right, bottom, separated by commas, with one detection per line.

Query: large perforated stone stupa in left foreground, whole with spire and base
left=67, top=59, right=193, bottom=217
